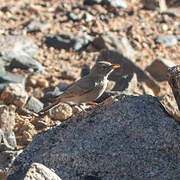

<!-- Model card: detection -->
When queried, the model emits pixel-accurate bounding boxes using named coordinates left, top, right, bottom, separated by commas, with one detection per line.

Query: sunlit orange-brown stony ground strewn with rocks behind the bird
left=0, top=0, right=180, bottom=179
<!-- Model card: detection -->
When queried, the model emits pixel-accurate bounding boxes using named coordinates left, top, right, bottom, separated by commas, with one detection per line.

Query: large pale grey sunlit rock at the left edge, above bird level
left=0, top=35, right=45, bottom=73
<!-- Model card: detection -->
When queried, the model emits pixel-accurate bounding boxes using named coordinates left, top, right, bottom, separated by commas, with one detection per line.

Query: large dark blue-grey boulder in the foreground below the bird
left=8, top=95, right=180, bottom=180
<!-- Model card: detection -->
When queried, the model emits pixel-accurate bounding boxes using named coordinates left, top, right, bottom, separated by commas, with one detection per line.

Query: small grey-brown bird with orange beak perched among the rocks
left=38, top=61, right=120, bottom=115
